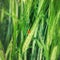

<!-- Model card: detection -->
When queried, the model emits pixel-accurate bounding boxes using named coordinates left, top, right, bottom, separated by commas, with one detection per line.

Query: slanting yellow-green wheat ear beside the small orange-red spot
left=22, top=18, right=39, bottom=53
